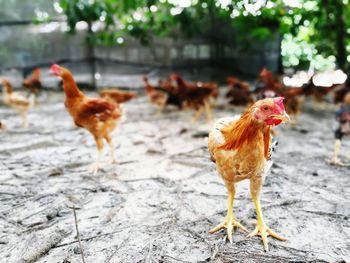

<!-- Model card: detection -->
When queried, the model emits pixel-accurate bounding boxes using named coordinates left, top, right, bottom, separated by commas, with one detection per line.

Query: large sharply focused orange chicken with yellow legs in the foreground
left=208, top=97, right=289, bottom=251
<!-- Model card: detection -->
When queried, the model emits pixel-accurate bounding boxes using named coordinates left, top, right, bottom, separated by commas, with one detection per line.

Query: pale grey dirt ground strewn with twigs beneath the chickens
left=0, top=92, right=350, bottom=263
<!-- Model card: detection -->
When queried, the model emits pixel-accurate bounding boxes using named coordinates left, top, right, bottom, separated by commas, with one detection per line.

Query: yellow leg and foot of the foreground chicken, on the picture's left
left=209, top=185, right=248, bottom=243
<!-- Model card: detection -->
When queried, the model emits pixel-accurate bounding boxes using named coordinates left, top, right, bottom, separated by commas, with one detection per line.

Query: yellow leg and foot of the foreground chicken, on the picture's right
left=248, top=177, right=286, bottom=252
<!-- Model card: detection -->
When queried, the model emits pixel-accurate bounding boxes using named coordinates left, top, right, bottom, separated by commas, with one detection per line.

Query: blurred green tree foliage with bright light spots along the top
left=55, top=0, right=350, bottom=71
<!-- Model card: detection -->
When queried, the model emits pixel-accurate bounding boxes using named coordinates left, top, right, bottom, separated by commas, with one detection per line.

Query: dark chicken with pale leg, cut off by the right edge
left=328, top=92, right=350, bottom=165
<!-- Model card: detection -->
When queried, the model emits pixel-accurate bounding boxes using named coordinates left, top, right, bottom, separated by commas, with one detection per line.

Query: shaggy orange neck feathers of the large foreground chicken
left=219, top=108, right=270, bottom=159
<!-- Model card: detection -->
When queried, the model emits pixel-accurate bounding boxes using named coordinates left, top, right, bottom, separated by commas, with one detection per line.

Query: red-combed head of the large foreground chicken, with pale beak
left=253, top=97, right=290, bottom=125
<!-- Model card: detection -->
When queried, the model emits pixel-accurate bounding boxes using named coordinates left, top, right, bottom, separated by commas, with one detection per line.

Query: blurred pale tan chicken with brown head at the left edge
left=2, top=79, right=35, bottom=128
